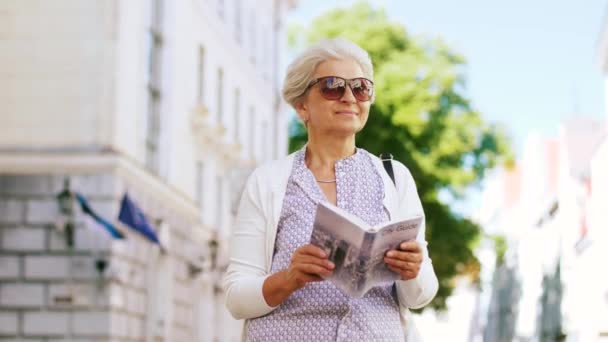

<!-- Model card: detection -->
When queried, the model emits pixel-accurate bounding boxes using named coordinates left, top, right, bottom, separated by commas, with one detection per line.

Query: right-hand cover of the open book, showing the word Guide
left=365, top=216, right=422, bottom=291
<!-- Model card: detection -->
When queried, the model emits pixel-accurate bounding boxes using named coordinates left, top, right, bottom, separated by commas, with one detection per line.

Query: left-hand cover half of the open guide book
left=310, top=203, right=374, bottom=297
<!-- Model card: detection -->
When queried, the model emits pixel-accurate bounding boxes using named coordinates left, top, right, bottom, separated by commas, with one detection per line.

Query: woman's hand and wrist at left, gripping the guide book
left=262, top=244, right=335, bottom=306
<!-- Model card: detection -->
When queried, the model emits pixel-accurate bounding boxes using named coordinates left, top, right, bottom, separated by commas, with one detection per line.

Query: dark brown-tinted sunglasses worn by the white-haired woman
left=307, top=76, right=374, bottom=102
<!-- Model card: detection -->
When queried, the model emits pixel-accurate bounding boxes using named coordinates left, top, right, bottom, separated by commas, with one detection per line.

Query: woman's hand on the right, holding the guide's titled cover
left=384, top=241, right=422, bottom=280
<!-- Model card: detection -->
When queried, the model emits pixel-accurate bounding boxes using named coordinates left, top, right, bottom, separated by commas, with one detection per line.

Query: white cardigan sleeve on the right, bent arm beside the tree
left=393, top=161, right=439, bottom=309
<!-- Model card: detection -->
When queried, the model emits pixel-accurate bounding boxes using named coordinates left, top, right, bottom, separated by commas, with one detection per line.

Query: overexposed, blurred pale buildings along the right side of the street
left=419, top=7, right=608, bottom=342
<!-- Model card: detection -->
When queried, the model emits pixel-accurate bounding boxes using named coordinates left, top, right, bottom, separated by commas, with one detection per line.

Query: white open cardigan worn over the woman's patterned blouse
left=223, top=152, right=438, bottom=342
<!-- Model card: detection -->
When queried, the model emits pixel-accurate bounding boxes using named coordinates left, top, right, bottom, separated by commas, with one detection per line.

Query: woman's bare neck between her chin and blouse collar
left=306, top=132, right=356, bottom=174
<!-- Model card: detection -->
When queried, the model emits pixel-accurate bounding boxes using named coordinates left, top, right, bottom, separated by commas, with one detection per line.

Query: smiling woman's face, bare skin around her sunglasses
left=296, top=59, right=371, bottom=137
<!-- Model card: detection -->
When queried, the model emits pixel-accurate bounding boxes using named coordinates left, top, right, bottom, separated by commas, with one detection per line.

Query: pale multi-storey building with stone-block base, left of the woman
left=0, top=0, right=295, bottom=341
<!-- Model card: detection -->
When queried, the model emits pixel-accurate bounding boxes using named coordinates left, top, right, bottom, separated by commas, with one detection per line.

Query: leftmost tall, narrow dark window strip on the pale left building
left=145, top=0, right=163, bottom=174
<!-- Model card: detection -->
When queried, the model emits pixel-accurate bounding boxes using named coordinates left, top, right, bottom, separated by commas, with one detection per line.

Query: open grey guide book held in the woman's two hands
left=310, top=203, right=422, bottom=298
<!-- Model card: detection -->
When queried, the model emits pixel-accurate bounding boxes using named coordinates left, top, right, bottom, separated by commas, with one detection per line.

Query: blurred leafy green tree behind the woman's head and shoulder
left=290, top=3, right=512, bottom=309
